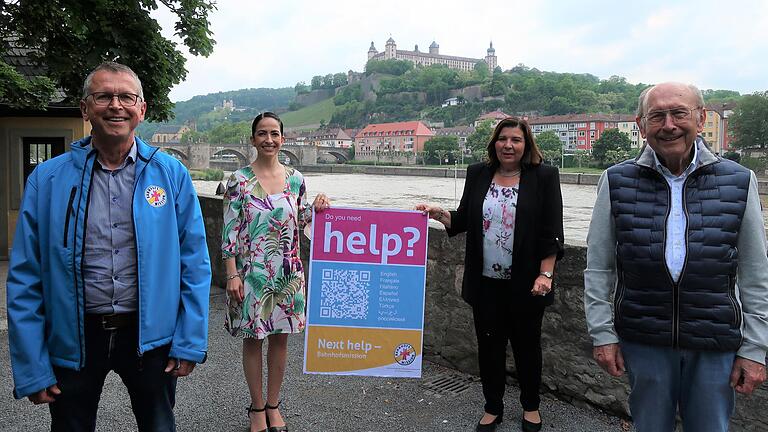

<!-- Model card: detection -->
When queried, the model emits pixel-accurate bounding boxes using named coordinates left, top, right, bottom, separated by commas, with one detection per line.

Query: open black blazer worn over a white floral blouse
left=446, top=163, right=563, bottom=305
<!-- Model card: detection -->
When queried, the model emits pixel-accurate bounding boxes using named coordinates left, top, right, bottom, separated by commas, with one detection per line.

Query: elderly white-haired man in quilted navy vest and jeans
left=584, top=83, right=768, bottom=432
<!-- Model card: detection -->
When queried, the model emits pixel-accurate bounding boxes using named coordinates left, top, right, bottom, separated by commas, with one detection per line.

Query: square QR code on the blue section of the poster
left=320, top=269, right=371, bottom=319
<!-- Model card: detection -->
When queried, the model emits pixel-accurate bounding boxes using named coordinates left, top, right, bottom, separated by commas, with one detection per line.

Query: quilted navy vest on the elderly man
left=608, top=159, right=750, bottom=351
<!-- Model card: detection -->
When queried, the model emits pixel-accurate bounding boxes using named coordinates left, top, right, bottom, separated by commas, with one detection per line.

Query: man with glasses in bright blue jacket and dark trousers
left=7, top=63, right=211, bottom=431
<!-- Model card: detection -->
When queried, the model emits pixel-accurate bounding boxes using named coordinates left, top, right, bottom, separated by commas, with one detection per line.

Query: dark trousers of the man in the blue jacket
left=50, top=319, right=176, bottom=432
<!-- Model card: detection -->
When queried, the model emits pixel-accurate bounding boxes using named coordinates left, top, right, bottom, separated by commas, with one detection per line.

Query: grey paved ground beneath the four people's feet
left=0, top=262, right=625, bottom=432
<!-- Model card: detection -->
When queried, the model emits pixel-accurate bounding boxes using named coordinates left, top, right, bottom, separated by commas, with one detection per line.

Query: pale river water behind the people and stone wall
left=194, top=173, right=597, bottom=245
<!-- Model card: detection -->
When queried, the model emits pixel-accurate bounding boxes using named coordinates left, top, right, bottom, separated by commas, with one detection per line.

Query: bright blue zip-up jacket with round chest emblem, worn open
left=7, top=137, right=211, bottom=399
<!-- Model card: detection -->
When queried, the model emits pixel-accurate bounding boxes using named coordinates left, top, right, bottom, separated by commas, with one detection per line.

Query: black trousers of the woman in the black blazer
left=472, top=277, right=544, bottom=415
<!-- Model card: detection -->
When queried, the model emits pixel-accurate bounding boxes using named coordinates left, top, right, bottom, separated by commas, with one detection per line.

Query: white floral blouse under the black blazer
left=483, top=182, right=519, bottom=279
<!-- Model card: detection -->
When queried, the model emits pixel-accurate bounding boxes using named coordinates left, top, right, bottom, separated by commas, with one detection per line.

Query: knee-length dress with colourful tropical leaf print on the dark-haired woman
left=221, top=166, right=308, bottom=339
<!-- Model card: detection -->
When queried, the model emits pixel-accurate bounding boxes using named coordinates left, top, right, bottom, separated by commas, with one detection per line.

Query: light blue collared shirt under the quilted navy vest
left=653, top=138, right=699, bottom=282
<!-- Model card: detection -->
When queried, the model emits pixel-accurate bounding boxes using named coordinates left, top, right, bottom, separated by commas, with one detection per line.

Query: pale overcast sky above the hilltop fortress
left=153, top=0, right=768, bottom=101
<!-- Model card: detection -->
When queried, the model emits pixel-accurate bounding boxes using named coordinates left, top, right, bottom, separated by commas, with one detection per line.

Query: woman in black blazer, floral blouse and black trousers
left=416, top=117, right=563, bottom=431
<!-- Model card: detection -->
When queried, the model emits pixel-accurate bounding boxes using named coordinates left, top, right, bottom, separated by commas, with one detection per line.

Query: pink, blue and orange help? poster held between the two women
left=304, top=208, right=428, bottom=378
